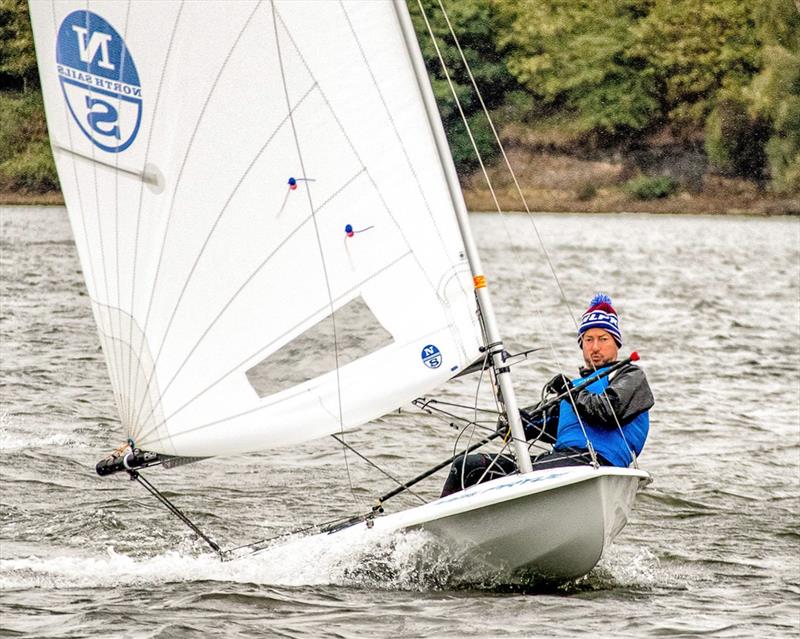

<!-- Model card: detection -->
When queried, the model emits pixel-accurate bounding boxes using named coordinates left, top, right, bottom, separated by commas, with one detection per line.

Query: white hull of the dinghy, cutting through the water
left=318, top=467, right=650, bottom=581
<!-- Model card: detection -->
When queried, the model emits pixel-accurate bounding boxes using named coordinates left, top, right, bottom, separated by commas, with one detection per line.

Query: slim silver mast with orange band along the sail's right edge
left=394, top=0, right=533, bottom=473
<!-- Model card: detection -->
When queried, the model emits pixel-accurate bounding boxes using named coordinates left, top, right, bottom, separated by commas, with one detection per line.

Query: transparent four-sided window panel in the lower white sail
left=247, top=297, right=394, bottom=397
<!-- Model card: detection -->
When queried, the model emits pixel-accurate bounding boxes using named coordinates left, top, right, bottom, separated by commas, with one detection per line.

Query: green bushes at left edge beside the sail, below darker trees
left=0, top=91, right=58, bottom=193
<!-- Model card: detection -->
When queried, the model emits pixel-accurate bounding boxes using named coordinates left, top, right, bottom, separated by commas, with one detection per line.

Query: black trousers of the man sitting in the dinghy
left=441, top=448, right=612, bottom=497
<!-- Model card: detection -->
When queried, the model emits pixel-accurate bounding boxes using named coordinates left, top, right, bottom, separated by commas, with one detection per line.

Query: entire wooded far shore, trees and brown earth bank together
left=0, top=0, right=800, bottom=215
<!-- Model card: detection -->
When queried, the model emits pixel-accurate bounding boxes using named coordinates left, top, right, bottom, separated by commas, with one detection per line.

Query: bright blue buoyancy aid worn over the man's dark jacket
left=553, top=367, right=650, bottom=467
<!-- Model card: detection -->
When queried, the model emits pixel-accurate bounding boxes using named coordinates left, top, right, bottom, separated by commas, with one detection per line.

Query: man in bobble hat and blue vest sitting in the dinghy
left=441, top=294, right=654, bottom=497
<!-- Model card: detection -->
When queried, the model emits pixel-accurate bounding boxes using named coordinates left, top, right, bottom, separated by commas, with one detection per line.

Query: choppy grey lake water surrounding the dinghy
left=0, top=208, right=800, bottom=637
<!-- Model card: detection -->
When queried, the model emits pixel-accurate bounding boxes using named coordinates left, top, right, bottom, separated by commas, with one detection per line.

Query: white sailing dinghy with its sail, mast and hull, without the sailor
left=30, top=0, right=649, bottom=580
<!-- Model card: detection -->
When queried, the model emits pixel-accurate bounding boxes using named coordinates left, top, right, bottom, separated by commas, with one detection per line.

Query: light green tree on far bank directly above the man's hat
left=498, top=0, right=659, bottom=143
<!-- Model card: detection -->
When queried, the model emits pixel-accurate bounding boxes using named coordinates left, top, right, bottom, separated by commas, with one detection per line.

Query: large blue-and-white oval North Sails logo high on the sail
left=56, top=10, right=142, bottom=153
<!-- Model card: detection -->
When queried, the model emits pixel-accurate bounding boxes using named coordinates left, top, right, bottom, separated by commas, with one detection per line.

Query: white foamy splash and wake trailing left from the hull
left=0, top=531, right=510, bottom=591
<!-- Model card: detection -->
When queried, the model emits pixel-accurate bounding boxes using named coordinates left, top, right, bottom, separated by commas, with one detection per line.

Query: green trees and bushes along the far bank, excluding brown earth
left=0, top=0, right=800, bottom=199
